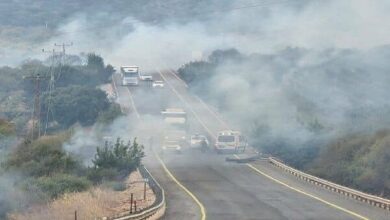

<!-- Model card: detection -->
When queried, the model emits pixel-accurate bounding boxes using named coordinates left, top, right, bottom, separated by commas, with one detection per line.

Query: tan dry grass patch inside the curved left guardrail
left=9, top=172, right=155, bottom=220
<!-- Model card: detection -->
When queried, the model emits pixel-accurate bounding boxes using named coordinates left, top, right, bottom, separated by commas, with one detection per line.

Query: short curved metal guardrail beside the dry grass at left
left=106, top=166, right=166, bottom=220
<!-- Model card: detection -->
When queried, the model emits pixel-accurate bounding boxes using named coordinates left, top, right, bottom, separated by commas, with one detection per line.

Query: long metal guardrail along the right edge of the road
left=268, top=157, right=390, bottom=211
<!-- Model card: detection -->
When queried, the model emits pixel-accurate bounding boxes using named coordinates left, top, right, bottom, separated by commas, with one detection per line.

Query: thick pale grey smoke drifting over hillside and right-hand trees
left=36, top=0, right=390, bottom=162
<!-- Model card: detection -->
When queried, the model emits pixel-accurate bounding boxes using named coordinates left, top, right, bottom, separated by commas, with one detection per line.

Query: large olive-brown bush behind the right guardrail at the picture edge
left=310, top=130, right=390, bottom=197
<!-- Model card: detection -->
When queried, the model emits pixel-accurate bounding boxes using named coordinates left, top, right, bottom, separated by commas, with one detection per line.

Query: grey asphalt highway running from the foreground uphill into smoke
left=111, top=71, right=390, bottom=220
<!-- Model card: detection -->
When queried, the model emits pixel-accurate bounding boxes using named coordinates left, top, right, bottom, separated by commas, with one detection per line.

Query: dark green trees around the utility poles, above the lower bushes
left=0, top=53, right=121, bottom=134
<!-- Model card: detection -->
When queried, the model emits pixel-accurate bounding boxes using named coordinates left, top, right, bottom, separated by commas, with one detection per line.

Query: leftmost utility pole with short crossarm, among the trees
left=23, top=73, right=48, bottom=139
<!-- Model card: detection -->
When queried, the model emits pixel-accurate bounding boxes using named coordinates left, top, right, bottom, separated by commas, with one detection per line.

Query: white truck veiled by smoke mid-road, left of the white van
left=161, top=108, right=188, bottom=152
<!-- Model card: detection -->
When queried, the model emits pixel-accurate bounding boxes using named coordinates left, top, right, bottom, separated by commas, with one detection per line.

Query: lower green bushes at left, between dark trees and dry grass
left=0, top=134, right=144, bottom=218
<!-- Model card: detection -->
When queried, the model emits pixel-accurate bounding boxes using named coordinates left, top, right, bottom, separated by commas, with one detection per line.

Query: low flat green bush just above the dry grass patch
left=26, top=174, right=91, bottom=199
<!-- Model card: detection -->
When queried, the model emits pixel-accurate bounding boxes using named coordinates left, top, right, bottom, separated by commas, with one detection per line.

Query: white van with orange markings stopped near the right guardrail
left=215, top=130, right=248, bottom=153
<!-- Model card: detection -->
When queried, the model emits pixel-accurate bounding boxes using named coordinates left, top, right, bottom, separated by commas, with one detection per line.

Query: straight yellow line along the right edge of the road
left=234, top=154, right=369, bottom=220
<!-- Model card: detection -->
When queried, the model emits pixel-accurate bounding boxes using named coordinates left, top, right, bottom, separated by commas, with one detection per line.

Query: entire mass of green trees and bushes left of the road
left=0, top=53, right=134, bottom=219
